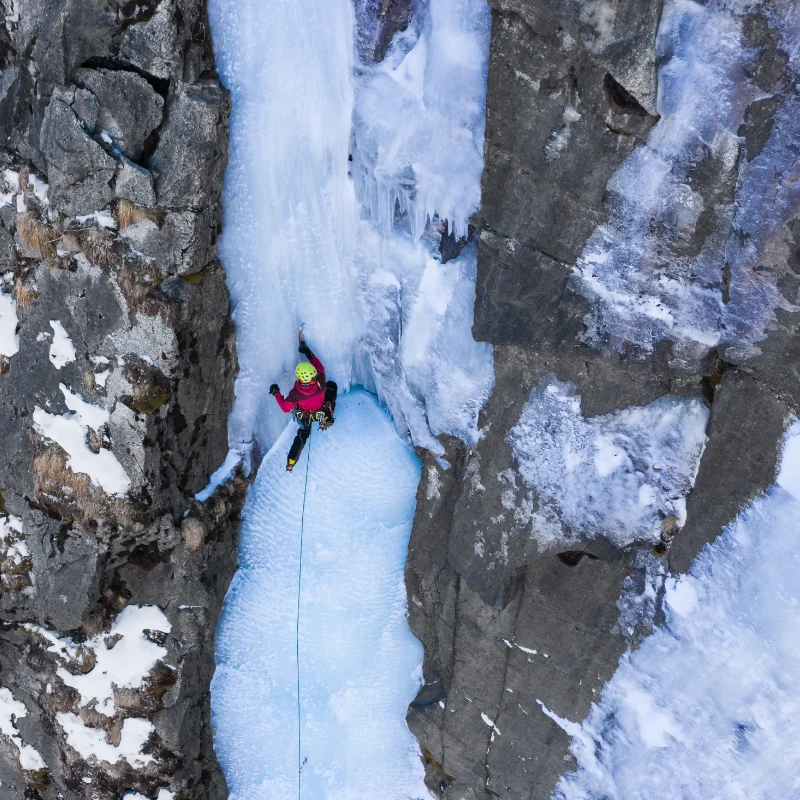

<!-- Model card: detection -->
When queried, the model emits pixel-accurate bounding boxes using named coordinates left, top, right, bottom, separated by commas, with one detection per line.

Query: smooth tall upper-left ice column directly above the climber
left=209, top=0, right=361, bottom=450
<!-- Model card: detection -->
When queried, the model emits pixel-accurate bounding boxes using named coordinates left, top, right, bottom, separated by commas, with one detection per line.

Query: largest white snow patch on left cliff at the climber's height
left=33, top=383, right=131, bottom=495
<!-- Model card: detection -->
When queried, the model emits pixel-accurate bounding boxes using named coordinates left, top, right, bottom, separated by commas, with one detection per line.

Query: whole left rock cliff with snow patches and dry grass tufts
left=0, top=0, right=239, bottom=800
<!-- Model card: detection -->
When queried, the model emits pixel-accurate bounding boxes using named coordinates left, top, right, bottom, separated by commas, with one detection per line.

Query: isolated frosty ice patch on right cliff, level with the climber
left=508, top=376, right=708, bottom=546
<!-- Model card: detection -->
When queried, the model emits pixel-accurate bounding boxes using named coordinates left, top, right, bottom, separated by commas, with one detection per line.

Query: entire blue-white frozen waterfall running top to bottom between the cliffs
left=203, top=0, right=493, bottom=800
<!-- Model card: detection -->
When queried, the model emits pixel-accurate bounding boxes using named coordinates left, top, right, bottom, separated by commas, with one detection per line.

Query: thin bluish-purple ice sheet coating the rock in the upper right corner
left=574, top=0, right=800, bottom=359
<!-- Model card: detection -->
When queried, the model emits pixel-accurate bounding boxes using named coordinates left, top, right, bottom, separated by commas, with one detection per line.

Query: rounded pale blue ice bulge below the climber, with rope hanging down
left=212, top=391, right=429, bottom=800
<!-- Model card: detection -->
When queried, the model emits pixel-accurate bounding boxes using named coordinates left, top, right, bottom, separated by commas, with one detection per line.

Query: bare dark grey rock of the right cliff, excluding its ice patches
left=406, top=0, right=800, bottom=800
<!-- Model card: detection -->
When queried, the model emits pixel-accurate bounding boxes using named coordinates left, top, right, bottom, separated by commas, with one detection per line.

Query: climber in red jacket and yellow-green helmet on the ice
left=269, top=339, right=338, bottom=472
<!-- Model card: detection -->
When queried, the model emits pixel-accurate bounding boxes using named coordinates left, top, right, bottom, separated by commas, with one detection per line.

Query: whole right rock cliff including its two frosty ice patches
left=406, top=0, right=800, bottom=800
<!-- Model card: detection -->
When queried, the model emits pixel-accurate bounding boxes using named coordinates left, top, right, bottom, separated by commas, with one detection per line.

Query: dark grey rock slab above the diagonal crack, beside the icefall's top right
left=478, top=0, right=660, bottom=268
